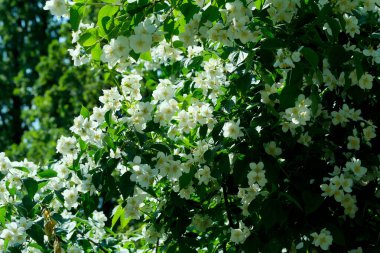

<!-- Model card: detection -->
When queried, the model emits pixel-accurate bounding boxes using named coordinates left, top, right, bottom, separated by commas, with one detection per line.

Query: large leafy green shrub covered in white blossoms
left=0, top=0, right=380, bottom=252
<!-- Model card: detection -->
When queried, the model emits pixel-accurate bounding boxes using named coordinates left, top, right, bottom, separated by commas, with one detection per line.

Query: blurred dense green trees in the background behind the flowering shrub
left=0, top=0, right=107, bottom=162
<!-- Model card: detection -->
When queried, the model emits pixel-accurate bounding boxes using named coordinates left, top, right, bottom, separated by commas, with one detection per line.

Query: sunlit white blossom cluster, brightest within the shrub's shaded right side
left=282, top=94, right=311, bottom=135
